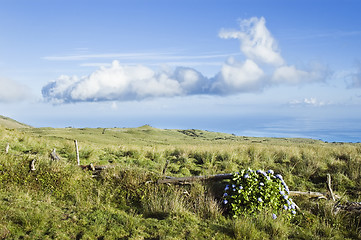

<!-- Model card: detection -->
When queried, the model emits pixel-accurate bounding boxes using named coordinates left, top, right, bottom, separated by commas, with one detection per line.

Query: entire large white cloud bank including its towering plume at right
left=42, top=17, right=327, bottom=103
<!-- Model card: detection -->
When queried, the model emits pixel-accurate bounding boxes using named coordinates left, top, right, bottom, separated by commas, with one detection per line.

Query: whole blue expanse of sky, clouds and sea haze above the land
left=0, top=0, right=361, bottom=142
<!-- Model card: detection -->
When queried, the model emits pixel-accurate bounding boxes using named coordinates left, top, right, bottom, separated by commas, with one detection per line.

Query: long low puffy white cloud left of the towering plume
left=42, top=61, right=206, bottom=103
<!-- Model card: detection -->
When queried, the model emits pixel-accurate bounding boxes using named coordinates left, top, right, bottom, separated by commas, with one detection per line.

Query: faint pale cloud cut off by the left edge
left=0, top=77, right=31, bottom=103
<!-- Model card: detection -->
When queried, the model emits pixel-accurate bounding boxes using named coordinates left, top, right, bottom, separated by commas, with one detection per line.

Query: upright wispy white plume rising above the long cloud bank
left=219, top=17, right=284, bottom=66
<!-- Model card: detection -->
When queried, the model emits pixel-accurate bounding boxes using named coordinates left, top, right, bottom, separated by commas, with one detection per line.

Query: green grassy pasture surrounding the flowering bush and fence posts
left=0, top=121, right=361, bottom=239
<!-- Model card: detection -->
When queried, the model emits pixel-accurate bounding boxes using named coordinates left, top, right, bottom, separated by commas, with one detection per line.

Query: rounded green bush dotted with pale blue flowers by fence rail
left=223, top=169, right=296, bottom=219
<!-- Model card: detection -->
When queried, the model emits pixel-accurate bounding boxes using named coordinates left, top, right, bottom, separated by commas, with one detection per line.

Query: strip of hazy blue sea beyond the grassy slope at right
left=165, top=118, right=361, bottom=143
